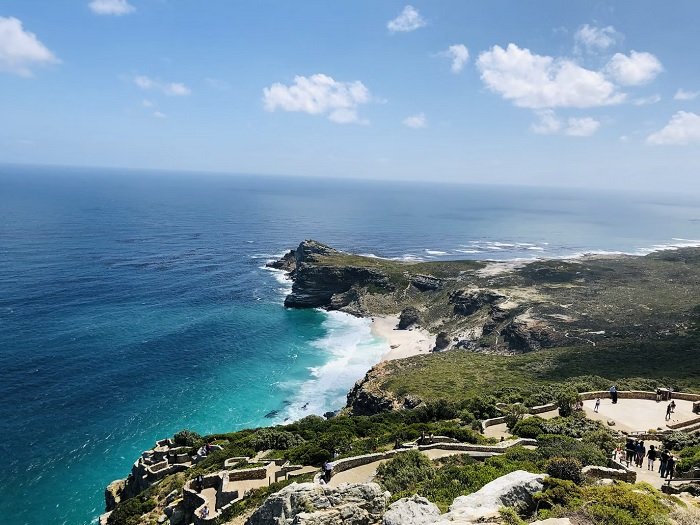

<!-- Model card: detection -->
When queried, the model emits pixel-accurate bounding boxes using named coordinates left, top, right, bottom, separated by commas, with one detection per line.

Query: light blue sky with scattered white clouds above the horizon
left=0, top=0, right=700, bottom=192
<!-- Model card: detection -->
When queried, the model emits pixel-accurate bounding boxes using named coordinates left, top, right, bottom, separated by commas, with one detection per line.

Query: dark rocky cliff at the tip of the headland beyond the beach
left=282, top=240, right=394, bottom=310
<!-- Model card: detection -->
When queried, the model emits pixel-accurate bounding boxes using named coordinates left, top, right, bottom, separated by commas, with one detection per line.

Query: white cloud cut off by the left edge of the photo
left=0, top=16, right=60, bottom=77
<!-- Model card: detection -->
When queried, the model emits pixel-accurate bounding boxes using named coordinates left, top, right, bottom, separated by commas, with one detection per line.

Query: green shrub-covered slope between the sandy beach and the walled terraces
left=378, top=337, right=700, bottom=406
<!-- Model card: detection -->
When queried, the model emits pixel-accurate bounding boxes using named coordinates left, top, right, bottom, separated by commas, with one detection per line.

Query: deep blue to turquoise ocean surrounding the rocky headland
left=0, top=166, right=700, bottom=525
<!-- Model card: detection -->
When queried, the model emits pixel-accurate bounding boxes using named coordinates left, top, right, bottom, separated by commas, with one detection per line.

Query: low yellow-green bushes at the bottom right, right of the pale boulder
left=535, top=478, right=673, bottom=525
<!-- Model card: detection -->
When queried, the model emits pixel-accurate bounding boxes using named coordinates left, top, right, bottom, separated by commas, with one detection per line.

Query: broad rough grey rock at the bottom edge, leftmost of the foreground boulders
left=246, top=483, right=389, bottom=525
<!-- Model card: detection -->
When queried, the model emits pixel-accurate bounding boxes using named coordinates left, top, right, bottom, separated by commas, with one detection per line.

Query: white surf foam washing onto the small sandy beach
left=283, top=312, right=389, bottom=420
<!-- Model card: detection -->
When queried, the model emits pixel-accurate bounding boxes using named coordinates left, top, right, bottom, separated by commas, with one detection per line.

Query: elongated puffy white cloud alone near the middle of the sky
left=263, top=74, right=371, bottom=124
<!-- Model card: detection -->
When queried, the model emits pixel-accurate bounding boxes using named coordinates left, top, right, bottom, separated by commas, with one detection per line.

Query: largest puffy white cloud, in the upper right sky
left=477, top=44, right=625, bottom=109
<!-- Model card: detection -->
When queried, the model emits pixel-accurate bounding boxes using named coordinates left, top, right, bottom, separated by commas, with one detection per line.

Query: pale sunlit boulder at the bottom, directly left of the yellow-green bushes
left=436, top=470, right=545, bottom=524
